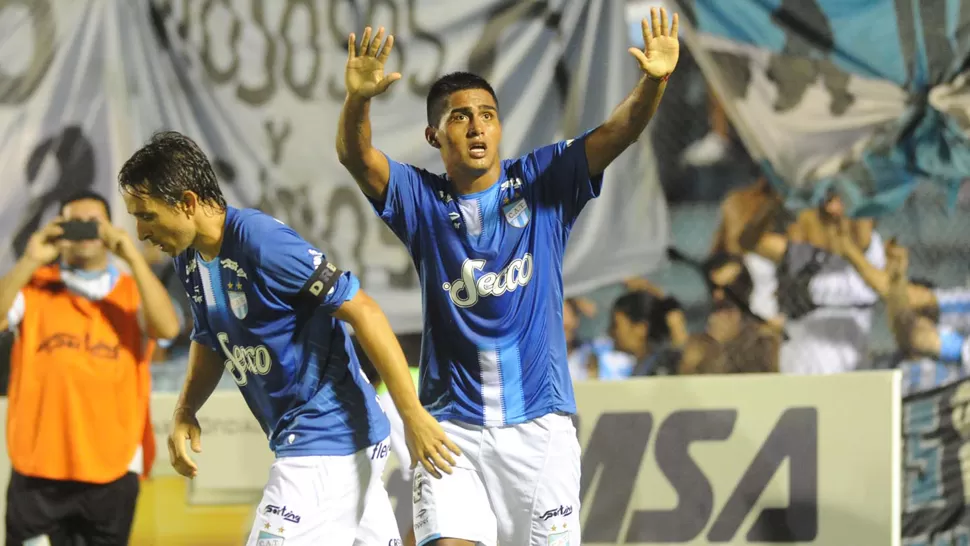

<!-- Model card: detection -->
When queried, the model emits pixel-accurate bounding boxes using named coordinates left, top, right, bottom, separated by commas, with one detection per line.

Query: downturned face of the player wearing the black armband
left=125, top=192, right=196, bottom=256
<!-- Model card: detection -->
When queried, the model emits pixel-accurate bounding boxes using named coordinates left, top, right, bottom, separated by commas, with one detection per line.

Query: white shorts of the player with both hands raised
left=412, top=414, right=580, bottom=546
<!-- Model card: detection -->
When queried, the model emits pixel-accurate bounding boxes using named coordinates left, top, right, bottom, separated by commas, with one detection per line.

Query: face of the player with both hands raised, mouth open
left=435, top=89, right=502, bottom=174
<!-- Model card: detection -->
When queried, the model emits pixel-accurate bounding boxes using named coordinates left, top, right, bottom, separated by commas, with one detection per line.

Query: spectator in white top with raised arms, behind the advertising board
left=742, top=197, right=885, bottom=374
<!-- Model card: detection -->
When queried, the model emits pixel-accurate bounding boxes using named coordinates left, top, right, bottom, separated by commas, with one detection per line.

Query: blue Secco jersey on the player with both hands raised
left=374, top=135, right=602, bottom=426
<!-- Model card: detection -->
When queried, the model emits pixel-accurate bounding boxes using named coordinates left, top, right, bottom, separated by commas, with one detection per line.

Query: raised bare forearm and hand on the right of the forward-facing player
left=584, top=8, right=680, bottom=176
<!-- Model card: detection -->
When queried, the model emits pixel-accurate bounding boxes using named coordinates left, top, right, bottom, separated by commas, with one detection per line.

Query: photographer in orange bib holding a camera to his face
left=0, top=193, right=179, bottom=546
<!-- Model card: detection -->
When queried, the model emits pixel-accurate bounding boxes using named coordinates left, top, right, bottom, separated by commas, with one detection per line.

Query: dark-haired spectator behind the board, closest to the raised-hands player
left=599, top=289, right=687, bottom=378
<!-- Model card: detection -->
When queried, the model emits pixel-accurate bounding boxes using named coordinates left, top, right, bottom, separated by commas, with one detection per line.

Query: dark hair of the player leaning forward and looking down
left=118, top=131, right=226, bottom=209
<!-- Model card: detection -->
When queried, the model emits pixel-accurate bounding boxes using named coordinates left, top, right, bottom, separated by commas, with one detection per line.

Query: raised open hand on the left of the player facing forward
left=344, top=27, right=401, bottom=99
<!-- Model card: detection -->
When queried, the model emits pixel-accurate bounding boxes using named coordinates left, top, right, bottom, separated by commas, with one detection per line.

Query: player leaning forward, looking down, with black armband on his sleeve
left=118, top=132, right=458, bottom=546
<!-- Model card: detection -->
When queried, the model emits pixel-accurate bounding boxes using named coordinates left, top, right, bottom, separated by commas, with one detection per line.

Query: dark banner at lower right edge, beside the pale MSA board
left=902, top=379, right=970, bottom=546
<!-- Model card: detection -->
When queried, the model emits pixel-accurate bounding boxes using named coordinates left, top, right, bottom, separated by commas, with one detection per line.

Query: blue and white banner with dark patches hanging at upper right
left=670, top=0, right=970, bottom=215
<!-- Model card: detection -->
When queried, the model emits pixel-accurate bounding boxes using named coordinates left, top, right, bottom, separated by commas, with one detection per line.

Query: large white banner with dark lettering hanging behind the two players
left=0, top=0, right=668, bottom=333
